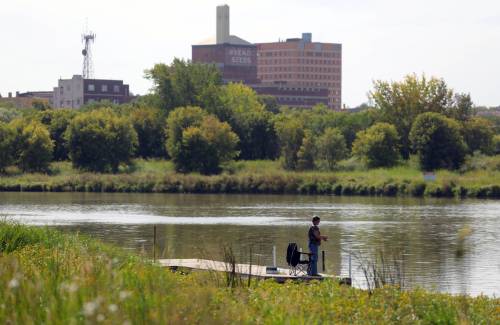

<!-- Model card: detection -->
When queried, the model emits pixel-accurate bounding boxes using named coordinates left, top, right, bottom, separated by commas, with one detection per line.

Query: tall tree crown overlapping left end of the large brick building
left=145, top=59, right=222, bottom=111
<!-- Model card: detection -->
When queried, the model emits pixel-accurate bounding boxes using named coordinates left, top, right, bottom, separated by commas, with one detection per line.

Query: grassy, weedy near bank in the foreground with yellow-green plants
left=0, top=223, right=500, bottom=324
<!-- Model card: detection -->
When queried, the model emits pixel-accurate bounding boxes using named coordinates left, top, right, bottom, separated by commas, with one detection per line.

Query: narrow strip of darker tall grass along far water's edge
left=0, top=172, right=500, bottom=199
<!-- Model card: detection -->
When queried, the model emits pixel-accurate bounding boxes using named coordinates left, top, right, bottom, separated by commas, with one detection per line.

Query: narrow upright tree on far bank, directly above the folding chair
left=275, top=117, right=304, bottom=170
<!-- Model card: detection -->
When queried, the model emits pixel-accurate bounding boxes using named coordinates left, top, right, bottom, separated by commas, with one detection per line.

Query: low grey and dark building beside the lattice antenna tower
left=52, top=75, right=133, bottom=108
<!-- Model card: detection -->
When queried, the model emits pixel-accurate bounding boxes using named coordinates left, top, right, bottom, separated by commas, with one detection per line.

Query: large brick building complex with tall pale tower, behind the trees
left=192, top=5, right=342, bottom=109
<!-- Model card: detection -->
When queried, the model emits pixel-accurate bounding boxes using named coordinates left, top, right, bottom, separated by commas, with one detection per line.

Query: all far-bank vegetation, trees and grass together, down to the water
left=0, top=60, right=500, bottom=197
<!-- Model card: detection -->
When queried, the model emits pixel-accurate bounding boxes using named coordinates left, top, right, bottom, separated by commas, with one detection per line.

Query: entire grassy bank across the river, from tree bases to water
left=0, top=156, right=500, bottom=198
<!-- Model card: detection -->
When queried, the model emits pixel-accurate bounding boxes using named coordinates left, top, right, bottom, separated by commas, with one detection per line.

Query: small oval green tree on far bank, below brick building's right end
left=317, top=128, right=348, bottom=170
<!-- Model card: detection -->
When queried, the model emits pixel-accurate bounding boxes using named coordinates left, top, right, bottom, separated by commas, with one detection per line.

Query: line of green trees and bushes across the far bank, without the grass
left=0, top=59, right=500, bottom=174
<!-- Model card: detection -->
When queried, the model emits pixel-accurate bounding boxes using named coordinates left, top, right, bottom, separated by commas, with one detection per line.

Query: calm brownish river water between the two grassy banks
left=0, top=193, right=500, bottom=297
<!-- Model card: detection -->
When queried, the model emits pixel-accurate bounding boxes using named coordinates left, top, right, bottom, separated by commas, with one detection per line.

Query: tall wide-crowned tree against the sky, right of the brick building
left=370, top=74, right=473, bottom=159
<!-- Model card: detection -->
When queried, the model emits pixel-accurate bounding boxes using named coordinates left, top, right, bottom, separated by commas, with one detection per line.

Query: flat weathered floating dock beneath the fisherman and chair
left=156, top=259, right=351, bottom=285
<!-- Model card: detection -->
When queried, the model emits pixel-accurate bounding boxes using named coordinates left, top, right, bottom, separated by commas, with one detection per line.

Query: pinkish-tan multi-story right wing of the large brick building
left=256, top=33, right=342, bottom=109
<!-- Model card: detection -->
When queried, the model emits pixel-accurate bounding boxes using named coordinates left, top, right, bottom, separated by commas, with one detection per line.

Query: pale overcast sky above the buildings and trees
left=0, top=0, right=500, bottom=106
